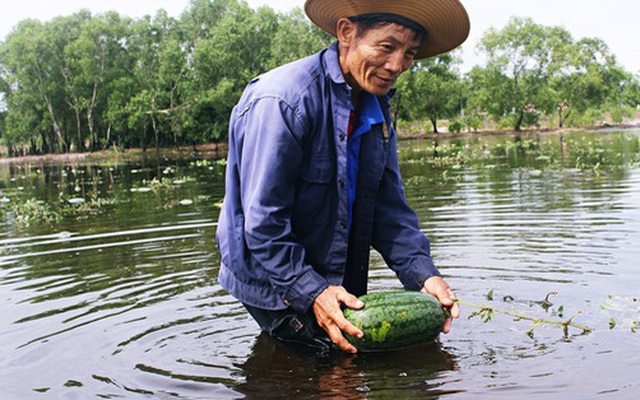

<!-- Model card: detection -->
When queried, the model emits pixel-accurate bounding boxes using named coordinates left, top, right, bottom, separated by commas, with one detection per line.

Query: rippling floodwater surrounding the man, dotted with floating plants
left=0, top=131, right=640, bottom=400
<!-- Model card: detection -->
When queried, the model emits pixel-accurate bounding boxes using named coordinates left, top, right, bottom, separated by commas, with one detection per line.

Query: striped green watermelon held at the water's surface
left=344, top=291, right=446, bottom=351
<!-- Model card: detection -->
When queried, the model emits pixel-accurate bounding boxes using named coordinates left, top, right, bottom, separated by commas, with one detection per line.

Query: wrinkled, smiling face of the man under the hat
left=338, top=19, right=420, bottom=96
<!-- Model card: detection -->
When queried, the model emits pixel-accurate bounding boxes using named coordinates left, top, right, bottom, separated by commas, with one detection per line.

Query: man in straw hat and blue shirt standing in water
left=217, top=0, right=469, bottom=352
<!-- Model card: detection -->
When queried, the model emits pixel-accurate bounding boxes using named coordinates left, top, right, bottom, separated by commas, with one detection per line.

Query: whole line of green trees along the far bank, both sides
left=0, top=0, right=640, bottom=155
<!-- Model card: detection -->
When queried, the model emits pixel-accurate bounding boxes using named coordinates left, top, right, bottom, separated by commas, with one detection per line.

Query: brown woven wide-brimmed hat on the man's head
left=304, top=0, right=470, bottom=59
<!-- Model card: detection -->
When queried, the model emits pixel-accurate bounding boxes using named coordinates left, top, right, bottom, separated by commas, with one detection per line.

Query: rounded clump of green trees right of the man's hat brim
left=468, top=18, right=640, bottom=130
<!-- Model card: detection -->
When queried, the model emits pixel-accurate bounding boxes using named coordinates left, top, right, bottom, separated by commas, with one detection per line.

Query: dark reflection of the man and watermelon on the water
left=235, top=334, right=457, bottom=399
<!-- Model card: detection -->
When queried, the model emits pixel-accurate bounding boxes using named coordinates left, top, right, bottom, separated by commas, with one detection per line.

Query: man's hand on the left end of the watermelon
left=313, top=286, right=364, bottom=353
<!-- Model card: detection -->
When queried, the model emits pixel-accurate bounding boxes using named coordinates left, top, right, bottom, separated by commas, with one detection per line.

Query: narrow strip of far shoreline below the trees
left=0, top=121, right=640, bottom=165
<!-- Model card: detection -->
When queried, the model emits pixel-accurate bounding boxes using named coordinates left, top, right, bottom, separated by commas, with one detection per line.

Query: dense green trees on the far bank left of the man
left=0, top=0, right=330, bottom=154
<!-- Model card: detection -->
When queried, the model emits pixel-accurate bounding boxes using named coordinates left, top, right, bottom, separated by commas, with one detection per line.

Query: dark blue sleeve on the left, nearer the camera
left=233, top=97, right=328, bottom=312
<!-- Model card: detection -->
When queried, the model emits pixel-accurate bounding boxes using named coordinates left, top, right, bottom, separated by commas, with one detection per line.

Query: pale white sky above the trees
left=0, top=0, right=640, bottom=74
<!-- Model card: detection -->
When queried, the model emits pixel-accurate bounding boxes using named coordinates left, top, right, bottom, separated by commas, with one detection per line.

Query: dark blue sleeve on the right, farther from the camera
left=372, top=131, right=441, bottom=290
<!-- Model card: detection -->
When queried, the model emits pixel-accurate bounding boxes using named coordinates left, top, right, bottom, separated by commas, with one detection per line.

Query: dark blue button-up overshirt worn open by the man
left=217, top=44, right=439, bottom=313
